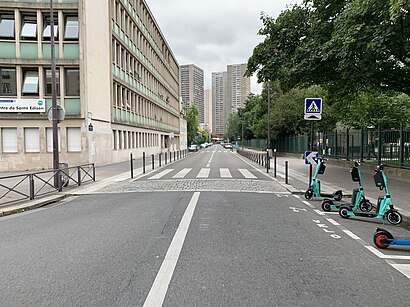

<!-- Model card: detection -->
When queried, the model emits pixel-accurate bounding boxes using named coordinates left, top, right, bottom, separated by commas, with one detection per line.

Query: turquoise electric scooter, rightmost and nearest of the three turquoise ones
left=339, top=165, right=403, bottom=225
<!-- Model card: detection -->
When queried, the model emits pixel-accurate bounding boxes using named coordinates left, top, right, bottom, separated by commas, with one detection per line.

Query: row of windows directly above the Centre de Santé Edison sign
left=0, top=66, right=80, bottom=97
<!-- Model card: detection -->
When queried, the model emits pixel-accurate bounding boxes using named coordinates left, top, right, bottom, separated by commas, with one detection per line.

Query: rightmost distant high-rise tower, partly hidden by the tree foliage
left=226, top=64, right=251, bottom=116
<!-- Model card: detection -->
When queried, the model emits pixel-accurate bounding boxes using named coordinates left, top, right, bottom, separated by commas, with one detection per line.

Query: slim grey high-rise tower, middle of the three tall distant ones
left=212, top=71, right=227, bottom=137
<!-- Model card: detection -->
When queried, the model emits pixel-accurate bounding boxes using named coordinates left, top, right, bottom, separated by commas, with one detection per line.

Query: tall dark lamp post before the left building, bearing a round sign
left=50, top=0, right=60, bottom=189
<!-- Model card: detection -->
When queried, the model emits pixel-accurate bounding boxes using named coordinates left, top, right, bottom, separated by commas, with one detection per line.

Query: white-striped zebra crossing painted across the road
left=148, top=167, right=258, bottom=180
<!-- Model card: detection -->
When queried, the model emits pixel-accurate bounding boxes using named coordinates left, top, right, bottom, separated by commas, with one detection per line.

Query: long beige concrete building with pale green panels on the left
left=0, top=0, right=186, bottom=171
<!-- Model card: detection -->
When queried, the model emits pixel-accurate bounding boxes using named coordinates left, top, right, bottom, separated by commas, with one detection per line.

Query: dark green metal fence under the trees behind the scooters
left=240, top=127, right=410, bottom=168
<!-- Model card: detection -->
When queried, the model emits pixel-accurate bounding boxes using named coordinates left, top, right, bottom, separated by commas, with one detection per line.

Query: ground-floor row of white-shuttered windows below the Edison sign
left=1, top=128, right=81, bottom=153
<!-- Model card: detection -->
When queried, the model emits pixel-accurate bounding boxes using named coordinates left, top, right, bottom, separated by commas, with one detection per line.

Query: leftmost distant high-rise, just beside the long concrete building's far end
left=180, top=64, right=204, bottom=124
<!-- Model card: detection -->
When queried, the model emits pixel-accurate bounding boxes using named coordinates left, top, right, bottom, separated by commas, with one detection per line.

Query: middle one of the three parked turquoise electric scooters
left=322, top=161, right=373, bottom=212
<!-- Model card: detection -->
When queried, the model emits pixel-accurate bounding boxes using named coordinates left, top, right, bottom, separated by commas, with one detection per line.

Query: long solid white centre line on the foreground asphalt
left=144, top=192, right=200, bottom=307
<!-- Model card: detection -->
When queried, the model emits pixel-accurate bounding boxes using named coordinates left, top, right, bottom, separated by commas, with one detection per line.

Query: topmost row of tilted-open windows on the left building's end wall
left=0, top=11, right=79, bottom=41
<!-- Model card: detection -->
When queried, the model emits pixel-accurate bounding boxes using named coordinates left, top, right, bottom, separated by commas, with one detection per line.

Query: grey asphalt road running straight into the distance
left=0, top=146, right=410, bottom=306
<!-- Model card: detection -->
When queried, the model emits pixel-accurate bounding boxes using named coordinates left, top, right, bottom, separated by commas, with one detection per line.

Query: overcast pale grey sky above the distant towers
left=147, top=0, right=301, bottom=93
